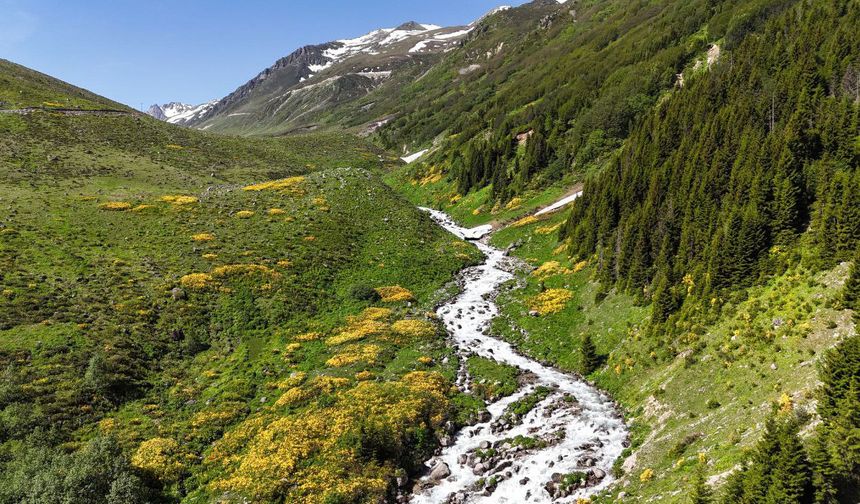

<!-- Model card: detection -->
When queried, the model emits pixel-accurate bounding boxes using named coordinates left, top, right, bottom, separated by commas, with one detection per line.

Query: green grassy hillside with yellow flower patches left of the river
left=0, top=69, right=490, bottom=502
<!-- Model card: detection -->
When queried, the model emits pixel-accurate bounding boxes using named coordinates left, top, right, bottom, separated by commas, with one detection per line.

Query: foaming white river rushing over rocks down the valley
left=411, top=209, right=628, bottom=504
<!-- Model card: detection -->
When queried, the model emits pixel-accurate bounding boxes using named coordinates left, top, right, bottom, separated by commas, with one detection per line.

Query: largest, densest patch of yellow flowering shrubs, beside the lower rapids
left=206, top=373, right=449, bottom=504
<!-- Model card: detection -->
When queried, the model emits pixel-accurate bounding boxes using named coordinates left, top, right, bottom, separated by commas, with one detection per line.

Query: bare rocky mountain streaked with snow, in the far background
left=187, top=21, right=474, bottom=132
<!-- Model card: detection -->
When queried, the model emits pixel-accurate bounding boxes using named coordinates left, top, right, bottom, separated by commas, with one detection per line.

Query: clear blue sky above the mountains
left=0, top=0, right=523, bottom=107
